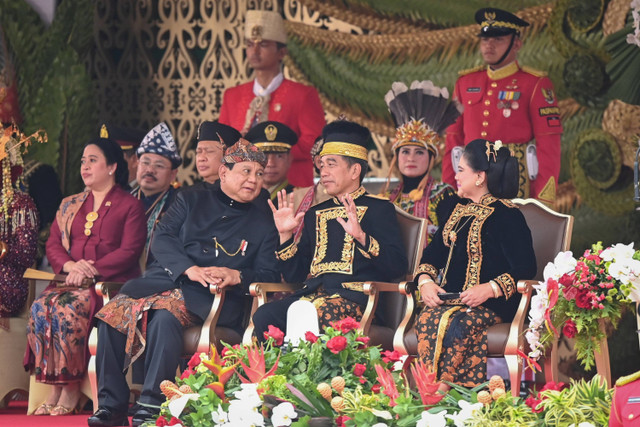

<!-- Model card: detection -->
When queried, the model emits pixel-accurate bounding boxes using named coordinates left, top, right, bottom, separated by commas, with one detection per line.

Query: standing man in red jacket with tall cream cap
left=218, top=10, right=325, bottom=187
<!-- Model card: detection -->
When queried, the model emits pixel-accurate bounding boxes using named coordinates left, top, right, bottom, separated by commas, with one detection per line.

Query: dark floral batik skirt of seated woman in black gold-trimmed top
left=416, top=305, right=501, bottom=387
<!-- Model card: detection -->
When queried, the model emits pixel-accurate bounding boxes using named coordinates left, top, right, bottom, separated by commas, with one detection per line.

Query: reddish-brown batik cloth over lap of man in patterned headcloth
left=96, top=289, right=197, bottom=367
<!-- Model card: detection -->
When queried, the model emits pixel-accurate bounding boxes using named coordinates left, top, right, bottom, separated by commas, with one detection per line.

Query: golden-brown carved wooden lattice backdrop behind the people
left=89, top=0, right=388, bottom=184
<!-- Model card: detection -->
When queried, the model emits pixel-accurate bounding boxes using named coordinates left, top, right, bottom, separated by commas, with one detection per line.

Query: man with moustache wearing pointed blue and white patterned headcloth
left=131, top=123, right=182, bottom=270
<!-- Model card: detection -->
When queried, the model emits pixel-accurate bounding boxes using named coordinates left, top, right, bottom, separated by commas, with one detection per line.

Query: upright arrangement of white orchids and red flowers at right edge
left=525, top=242, right=640, bottom=369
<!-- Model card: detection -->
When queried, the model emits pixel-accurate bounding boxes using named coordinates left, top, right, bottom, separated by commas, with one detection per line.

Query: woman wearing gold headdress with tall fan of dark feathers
left=383, top=80, right=460, bottom=244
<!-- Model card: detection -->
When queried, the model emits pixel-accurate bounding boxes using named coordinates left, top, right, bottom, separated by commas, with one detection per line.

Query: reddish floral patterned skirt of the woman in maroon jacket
left=27, top=288, right=91, bottom=384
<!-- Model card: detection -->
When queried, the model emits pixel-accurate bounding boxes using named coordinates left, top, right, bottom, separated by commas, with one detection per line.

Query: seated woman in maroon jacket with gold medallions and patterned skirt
left=24, top=129, right=147, bottom=415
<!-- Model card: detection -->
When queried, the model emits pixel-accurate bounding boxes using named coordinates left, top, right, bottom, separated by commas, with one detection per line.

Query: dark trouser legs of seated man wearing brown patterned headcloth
left=96, top=310, right=183, bottom=412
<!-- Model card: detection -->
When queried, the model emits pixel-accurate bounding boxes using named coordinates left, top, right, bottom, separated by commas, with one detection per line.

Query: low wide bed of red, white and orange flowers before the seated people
left=145, top=318, right=616, bottom=427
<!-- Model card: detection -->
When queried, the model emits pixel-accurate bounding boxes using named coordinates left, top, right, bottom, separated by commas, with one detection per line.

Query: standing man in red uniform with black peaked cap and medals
left=442, top=8, right=562, bottom=204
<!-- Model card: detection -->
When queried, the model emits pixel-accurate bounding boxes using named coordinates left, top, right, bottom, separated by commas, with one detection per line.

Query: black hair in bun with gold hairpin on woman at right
left=463, top=139, right=519, bottom=199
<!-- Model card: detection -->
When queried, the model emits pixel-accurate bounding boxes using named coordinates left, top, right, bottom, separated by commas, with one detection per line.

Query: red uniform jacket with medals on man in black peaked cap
left=442, top=62, right=562, bottom=198
